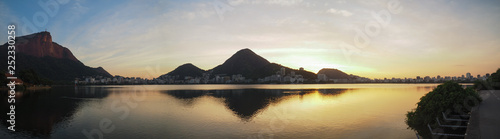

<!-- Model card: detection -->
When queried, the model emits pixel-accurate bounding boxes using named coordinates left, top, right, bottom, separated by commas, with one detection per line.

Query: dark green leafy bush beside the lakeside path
left=405, top=81, right=482, bottom=130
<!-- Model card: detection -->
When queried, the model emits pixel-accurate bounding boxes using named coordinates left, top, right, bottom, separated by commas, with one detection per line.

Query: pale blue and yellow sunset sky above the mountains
left=0, top=0, right=500, bottom=79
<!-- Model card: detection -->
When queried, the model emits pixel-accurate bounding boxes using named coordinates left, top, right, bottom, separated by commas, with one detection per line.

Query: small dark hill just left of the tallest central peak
left=160, top=63, right=205, bottom=79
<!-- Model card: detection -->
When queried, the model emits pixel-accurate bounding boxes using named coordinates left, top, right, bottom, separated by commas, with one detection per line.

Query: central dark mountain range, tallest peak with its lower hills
left=160, top=48, right=350, bottom=79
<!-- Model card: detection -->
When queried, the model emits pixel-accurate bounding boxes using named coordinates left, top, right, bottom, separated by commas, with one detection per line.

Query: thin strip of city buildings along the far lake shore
left=75, top=68, right=490, bottom=85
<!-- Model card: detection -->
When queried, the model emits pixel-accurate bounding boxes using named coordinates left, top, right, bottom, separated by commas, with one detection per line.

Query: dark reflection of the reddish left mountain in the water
left=0, top=87, right=109, bottom=138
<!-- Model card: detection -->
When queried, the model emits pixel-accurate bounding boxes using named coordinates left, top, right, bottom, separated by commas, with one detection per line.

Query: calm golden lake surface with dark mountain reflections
left=0, top=84, right=437, bottom=139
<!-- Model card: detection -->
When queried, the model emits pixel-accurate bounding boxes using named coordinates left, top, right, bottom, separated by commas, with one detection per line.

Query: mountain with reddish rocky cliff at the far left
left=0, top=31, right=111, bottom=81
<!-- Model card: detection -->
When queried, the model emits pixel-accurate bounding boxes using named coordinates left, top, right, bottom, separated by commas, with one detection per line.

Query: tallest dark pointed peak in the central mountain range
left=209, top=48, right=270, bottom=77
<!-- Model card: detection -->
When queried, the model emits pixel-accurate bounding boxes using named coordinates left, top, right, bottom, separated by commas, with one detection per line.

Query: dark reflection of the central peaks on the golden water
left=163, top=89, right=346, bottom=121
